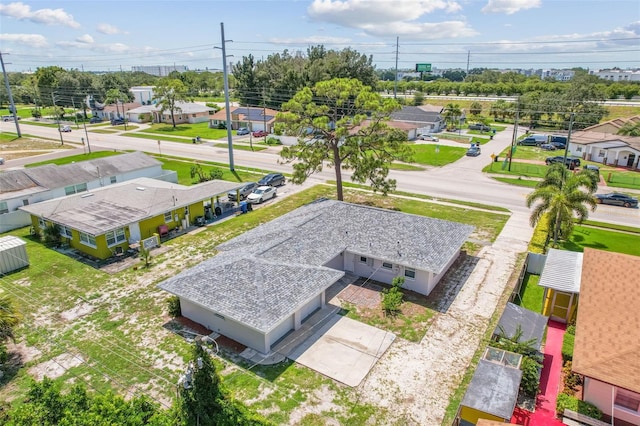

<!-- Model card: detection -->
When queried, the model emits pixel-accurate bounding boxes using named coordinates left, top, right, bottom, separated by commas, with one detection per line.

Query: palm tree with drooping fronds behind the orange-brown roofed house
left=527, top=164, right=598, bottom=250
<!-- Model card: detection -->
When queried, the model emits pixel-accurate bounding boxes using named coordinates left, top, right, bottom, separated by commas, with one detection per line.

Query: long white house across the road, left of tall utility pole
left=125, top=102, right=215, bottom=124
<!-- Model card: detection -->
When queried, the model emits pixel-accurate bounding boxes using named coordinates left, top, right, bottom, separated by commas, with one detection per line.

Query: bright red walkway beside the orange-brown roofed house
left=511, top=321, right=567, bottom=426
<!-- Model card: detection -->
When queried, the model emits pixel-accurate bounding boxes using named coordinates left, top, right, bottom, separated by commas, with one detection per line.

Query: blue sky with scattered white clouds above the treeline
left=0, top=0, right=640, bottom=71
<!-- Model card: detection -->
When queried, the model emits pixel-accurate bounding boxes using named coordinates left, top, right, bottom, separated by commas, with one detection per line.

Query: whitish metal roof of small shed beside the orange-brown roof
left=538, top=249, right=583, bottom=293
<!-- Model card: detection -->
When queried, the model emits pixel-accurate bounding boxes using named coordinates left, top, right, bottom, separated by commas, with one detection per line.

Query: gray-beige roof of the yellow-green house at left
left=21, top=178, right=243, bottom=235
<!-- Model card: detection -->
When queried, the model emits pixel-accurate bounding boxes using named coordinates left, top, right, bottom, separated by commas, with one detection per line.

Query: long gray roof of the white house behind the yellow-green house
left=0, top=152, right=162, bottom=193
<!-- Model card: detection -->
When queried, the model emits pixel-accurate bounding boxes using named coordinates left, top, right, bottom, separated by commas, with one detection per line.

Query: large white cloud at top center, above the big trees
left=307, top=0, right=470, bottom=39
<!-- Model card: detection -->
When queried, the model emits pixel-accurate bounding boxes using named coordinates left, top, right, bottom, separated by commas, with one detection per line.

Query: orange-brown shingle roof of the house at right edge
left=573, top=248, right=640, bottom=392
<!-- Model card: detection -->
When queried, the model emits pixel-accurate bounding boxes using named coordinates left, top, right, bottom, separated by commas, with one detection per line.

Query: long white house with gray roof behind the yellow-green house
left=0, top=152, right=178, bottom=232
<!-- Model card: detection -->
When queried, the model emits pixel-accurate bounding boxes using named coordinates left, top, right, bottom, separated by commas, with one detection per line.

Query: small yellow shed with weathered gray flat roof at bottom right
left=457, top=359, right=522, bottom=426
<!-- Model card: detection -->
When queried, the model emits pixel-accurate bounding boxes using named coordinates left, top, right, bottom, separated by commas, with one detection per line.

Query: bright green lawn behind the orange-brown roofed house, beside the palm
left=560, top=225, right=640, bottom=256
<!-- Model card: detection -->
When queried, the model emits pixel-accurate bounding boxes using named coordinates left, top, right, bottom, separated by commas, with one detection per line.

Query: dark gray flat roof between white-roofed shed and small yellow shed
left=493, top=302, right=549, bottom=351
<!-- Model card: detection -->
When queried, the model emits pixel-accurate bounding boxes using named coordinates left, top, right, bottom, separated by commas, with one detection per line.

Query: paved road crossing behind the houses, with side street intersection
left=0, top=122, right=640, bottom=226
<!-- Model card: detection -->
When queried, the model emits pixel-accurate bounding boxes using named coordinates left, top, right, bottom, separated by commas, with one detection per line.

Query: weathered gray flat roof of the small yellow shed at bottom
left=461, top=359, right=522, bottom=419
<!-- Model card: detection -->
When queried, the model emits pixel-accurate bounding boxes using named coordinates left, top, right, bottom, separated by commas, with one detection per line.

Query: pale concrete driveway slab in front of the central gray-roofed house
left=287, top=310, right=396, bottom=386
